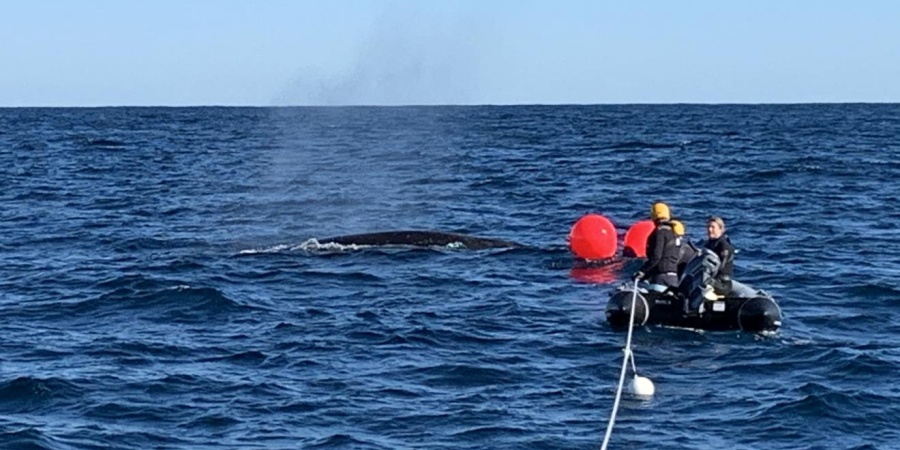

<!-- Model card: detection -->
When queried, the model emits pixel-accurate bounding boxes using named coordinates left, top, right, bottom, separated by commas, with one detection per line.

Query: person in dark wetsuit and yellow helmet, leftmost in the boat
left=634, top=202, right=679, bottom=287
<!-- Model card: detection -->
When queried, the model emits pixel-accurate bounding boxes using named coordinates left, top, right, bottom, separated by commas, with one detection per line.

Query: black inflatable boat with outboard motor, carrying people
left=606, top=249, right=782, bottom=333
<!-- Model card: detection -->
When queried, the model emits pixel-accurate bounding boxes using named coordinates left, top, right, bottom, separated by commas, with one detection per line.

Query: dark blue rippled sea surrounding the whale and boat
left=0, top=104, right=900, bottom=450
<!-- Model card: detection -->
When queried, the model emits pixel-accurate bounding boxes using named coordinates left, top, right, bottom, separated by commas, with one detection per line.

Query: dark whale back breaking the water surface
left=316, top=230, right=525, bottom=250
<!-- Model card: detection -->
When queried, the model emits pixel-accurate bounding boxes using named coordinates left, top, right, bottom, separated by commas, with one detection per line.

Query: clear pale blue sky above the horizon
left=0, top=0, right=900, bottom=106
